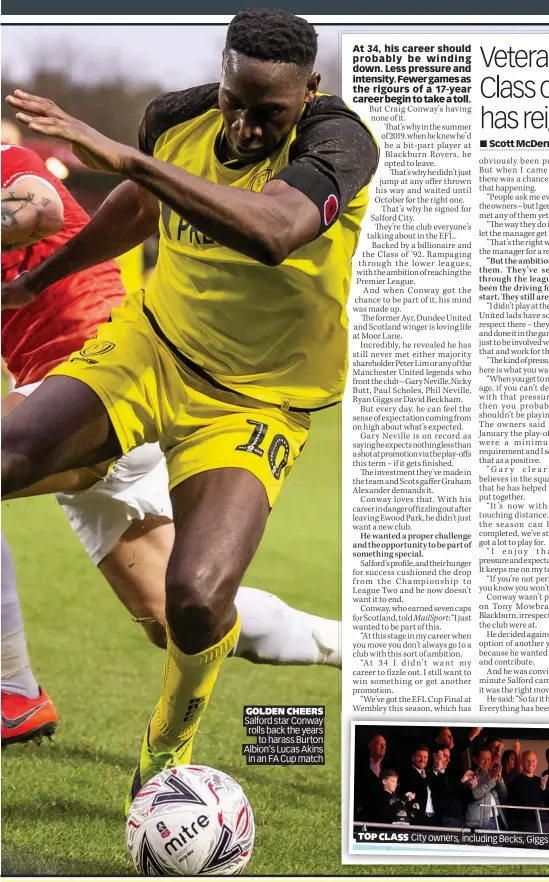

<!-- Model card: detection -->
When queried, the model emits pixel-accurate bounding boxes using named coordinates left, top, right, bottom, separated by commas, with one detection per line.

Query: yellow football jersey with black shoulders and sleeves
left=140, top=84, right=378, bottom=410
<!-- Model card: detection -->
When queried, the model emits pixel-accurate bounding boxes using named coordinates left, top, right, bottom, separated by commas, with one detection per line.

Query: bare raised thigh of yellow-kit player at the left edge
left=2, top=376, right=121, bottom=495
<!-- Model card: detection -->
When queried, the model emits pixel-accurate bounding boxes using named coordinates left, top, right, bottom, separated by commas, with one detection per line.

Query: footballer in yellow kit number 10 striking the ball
left=4, top=9, right=378, bottom=816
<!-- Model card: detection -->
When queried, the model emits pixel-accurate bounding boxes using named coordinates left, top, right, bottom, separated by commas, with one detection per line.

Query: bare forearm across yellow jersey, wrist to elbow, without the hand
left=123, top=150, right=320, bottom=266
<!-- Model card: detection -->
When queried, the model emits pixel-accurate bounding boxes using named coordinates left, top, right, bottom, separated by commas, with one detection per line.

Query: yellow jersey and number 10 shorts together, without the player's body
left=45, top=83, right=376, bottom=505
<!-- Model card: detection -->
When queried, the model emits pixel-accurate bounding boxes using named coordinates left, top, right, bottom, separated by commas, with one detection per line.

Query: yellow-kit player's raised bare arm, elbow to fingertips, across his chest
left=7, top=90, right=321, bottom=266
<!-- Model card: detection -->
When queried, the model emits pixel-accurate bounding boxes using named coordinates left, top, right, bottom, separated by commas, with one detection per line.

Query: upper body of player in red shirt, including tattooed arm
left=2, top=145, right=125, bottom=386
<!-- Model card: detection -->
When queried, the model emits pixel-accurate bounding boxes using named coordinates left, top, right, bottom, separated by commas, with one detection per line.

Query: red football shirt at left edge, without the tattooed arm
left=2, top=144, right=125, bottom=386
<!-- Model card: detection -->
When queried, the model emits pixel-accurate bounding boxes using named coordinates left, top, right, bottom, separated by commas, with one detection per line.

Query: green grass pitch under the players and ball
left=2, top=409, right=547, bottom=876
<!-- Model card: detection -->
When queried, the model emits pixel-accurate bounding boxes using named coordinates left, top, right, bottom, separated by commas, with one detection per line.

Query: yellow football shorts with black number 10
left=49, top=292, right=310, bottom=506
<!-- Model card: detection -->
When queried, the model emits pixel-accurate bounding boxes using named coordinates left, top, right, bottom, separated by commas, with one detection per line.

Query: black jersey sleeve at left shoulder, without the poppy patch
left=139, top=83, right=219, bottom=156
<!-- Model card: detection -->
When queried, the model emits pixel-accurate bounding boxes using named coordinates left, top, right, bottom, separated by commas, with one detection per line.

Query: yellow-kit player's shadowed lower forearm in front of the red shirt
left=11, top=181, right=158, bottom=294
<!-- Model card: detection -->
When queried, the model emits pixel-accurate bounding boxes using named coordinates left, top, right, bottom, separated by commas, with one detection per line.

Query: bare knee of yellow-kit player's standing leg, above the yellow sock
left=162, top=566, right=232, bottom=654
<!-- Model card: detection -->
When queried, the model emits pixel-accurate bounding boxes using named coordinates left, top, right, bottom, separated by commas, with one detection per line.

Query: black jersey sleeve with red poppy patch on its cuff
left=276, top=95, right=379, bottom=236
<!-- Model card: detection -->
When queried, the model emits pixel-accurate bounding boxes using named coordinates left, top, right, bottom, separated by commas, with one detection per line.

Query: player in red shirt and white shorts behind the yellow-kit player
left=2, top=139, right=340, bottom=744
